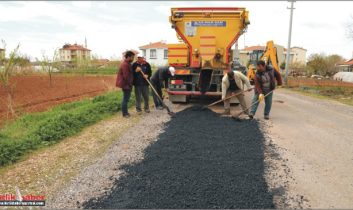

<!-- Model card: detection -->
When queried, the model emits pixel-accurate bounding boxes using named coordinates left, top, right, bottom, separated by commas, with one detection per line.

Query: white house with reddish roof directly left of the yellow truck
left=139, top=41, right=168, bottom=66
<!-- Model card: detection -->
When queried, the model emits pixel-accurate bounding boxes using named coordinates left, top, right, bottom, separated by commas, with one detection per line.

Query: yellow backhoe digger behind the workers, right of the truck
left=247, top=41, right=281, bottom=84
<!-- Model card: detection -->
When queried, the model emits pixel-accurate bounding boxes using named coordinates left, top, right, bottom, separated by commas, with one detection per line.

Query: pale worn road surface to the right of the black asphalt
left=266, top=90, right=353, bottom=208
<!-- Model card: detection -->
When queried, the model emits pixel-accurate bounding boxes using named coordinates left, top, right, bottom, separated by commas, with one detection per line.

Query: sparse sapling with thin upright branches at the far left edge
left=0, top=40, right=20, bottom=118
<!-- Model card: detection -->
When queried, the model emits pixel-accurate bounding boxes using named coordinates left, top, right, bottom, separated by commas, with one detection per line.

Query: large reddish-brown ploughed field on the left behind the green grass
left=0, top=75, right=115, bottom=124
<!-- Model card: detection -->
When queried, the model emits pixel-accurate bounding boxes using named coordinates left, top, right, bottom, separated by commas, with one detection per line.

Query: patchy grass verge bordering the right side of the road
left=289, top=86, right=353, bottom=106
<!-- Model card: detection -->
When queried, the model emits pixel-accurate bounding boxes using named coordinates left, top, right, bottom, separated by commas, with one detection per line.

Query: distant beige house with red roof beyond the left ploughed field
left=59, top=42, right=91, bottom=64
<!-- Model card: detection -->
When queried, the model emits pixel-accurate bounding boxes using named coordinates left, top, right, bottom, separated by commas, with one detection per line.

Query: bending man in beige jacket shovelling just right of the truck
left=222, top=69, right=251, bottom=115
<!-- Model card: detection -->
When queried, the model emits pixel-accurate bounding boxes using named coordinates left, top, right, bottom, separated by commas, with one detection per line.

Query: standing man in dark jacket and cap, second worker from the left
left=132, top=56, right=152, bottom=113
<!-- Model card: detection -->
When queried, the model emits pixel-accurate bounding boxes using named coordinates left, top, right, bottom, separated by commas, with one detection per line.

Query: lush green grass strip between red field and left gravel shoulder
left=0, top=91, right=134, bottom=166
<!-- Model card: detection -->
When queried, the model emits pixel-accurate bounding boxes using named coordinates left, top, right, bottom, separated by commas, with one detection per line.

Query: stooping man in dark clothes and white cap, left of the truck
left=151, top=66, right=175, bottom=110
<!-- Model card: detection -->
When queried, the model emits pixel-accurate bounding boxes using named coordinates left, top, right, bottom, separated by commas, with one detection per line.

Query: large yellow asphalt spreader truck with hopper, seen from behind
left=168, top=7, right=250, bottom=102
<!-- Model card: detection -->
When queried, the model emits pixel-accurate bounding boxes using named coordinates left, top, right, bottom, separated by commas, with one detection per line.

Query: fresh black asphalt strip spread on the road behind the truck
left=83, top=107, right=275, bottom=209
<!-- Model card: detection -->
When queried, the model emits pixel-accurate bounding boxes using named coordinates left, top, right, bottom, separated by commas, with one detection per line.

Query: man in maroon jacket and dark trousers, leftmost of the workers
left=116, top=51, right=135, bottom=118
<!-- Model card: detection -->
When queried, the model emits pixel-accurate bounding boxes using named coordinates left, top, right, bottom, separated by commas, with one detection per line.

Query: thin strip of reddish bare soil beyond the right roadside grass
left=288, top=77, right=353, bottom=88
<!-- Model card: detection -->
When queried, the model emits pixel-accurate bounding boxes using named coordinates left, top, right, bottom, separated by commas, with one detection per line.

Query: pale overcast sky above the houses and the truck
left=0, top=1, right=353, bottom=60
